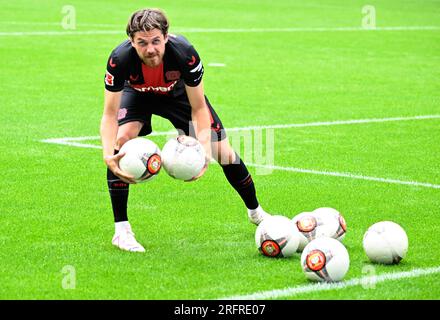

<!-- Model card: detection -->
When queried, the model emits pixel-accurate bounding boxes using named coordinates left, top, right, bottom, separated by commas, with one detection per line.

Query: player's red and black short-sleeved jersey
left=104, top=34, right=203, bottom=96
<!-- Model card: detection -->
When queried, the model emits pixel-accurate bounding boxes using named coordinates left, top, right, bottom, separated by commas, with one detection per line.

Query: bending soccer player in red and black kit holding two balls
left=100, top=9, right=268, bottom=252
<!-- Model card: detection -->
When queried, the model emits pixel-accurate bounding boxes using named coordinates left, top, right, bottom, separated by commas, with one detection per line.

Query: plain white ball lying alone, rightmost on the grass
left=362, top=221, right=408, bottom=264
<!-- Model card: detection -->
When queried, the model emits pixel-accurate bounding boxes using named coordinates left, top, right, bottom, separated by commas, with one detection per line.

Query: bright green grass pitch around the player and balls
left=0, top=0, right=440, bottom=300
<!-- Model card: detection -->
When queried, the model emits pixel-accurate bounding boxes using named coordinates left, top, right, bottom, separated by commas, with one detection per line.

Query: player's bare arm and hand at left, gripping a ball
left=100, top=89, right=135, bottom=183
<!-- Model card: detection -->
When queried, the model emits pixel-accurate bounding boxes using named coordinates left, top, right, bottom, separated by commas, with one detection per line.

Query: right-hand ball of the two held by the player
left=162, top=135, right=206, bottom=181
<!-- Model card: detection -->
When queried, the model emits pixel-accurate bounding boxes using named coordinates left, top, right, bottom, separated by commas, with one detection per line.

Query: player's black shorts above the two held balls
left=118, top=86, right=226, bottom=142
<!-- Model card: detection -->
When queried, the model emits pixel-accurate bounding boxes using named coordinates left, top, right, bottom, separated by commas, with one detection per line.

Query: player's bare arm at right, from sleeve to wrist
left=185, top=81, right=211, bottom=162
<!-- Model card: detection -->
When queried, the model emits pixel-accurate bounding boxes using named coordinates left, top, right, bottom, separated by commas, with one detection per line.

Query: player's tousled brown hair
left=127, top=9, right=170, bottom=39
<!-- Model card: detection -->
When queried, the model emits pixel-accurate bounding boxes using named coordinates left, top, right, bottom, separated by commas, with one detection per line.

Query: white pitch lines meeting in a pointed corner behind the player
left=41, top=115, right=440, bottom=189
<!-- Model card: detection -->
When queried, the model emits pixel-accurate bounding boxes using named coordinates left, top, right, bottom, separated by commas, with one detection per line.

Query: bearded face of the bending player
left=131, top=29, right=168, bottom=67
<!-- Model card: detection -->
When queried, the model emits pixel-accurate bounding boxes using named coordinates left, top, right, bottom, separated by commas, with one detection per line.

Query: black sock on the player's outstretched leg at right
left=222, top=153, right=258, bottom=209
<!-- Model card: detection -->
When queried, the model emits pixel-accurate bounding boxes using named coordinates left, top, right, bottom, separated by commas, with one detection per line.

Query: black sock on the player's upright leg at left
left=107, top=150, right=129, bottom=222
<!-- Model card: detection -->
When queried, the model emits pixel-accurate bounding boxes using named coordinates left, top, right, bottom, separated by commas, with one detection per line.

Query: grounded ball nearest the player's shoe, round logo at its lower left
left=255, top=216, right=299, bottom=257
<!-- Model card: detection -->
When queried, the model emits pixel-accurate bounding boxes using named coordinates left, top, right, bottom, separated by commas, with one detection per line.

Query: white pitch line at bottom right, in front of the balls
left=218, top=267, right=440, bottom=300
